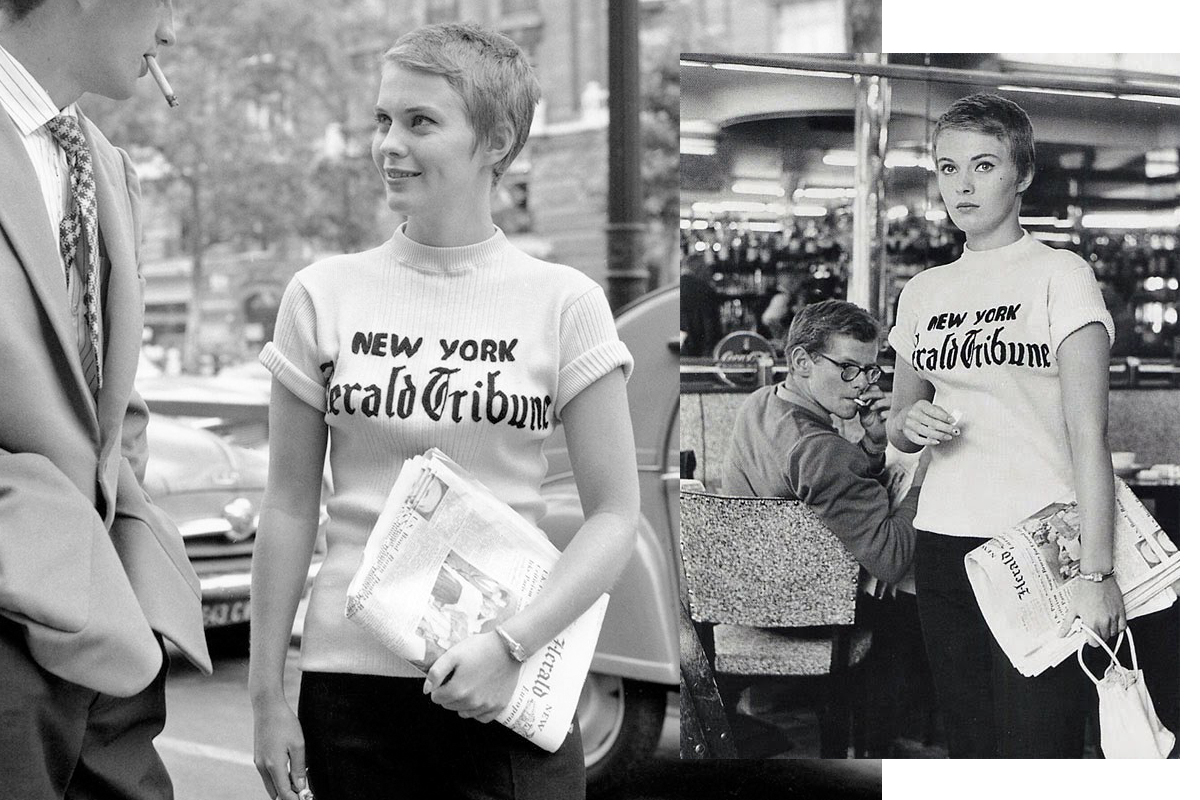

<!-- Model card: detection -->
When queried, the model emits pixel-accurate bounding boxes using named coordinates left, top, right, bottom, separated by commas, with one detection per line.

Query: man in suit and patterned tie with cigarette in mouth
left=0, top=0, right=211, bottom=800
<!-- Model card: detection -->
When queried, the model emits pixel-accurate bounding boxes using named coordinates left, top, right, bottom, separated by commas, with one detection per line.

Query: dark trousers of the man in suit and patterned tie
left=0, top=618, right=174, bottom=800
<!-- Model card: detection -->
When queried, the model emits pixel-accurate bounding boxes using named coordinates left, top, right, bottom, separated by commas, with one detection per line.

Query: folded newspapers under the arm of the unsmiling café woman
left=966, top=479, right=1180, bottom=676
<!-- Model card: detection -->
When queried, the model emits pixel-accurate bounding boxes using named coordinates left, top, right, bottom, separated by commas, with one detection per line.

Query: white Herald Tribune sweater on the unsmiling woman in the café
left=888, top=234, right=1112, bottom=537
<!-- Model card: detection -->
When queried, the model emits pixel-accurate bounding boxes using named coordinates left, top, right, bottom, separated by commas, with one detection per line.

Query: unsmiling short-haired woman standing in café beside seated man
left=888, top=95, right=1126, bottom=758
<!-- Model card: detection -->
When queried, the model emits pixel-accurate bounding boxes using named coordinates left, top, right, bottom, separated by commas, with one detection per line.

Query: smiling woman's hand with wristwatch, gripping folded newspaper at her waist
left=425, top=631, right=521, bottom=722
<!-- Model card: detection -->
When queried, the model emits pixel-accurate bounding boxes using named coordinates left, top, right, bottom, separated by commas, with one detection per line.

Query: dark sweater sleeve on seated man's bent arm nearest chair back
left=788, top=431, right=919, bottom=583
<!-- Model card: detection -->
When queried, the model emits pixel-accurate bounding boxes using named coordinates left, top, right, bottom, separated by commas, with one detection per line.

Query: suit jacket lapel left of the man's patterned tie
left=0, top=113, right=88, bottom=381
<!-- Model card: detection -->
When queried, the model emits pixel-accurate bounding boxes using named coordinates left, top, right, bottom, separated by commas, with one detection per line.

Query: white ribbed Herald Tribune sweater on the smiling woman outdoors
left=259, top=229, right=632, bottom=676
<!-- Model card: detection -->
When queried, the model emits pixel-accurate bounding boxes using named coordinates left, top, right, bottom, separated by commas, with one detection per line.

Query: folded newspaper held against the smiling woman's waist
left=346, top=447, right=608, bottom=752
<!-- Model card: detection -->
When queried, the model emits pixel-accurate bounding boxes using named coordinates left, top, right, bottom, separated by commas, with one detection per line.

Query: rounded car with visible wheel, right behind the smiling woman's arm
left=541, top=284, right=679, bottom=796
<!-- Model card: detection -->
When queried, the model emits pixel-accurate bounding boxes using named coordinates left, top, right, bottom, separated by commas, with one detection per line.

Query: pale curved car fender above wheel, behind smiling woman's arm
left=540, top=479, right=679, bottom=686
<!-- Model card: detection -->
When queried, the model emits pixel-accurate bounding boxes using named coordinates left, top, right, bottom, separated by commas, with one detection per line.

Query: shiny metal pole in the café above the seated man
left=846, top=53, right=892, bottom=320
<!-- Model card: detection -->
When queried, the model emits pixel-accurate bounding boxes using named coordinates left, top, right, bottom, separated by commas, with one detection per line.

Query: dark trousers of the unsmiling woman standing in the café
left=916, top=531, right=1094, bottom=758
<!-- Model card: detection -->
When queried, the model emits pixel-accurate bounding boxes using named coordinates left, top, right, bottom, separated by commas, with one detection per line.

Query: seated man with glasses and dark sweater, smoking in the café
left=721, top=300, right=931, bottom=758
